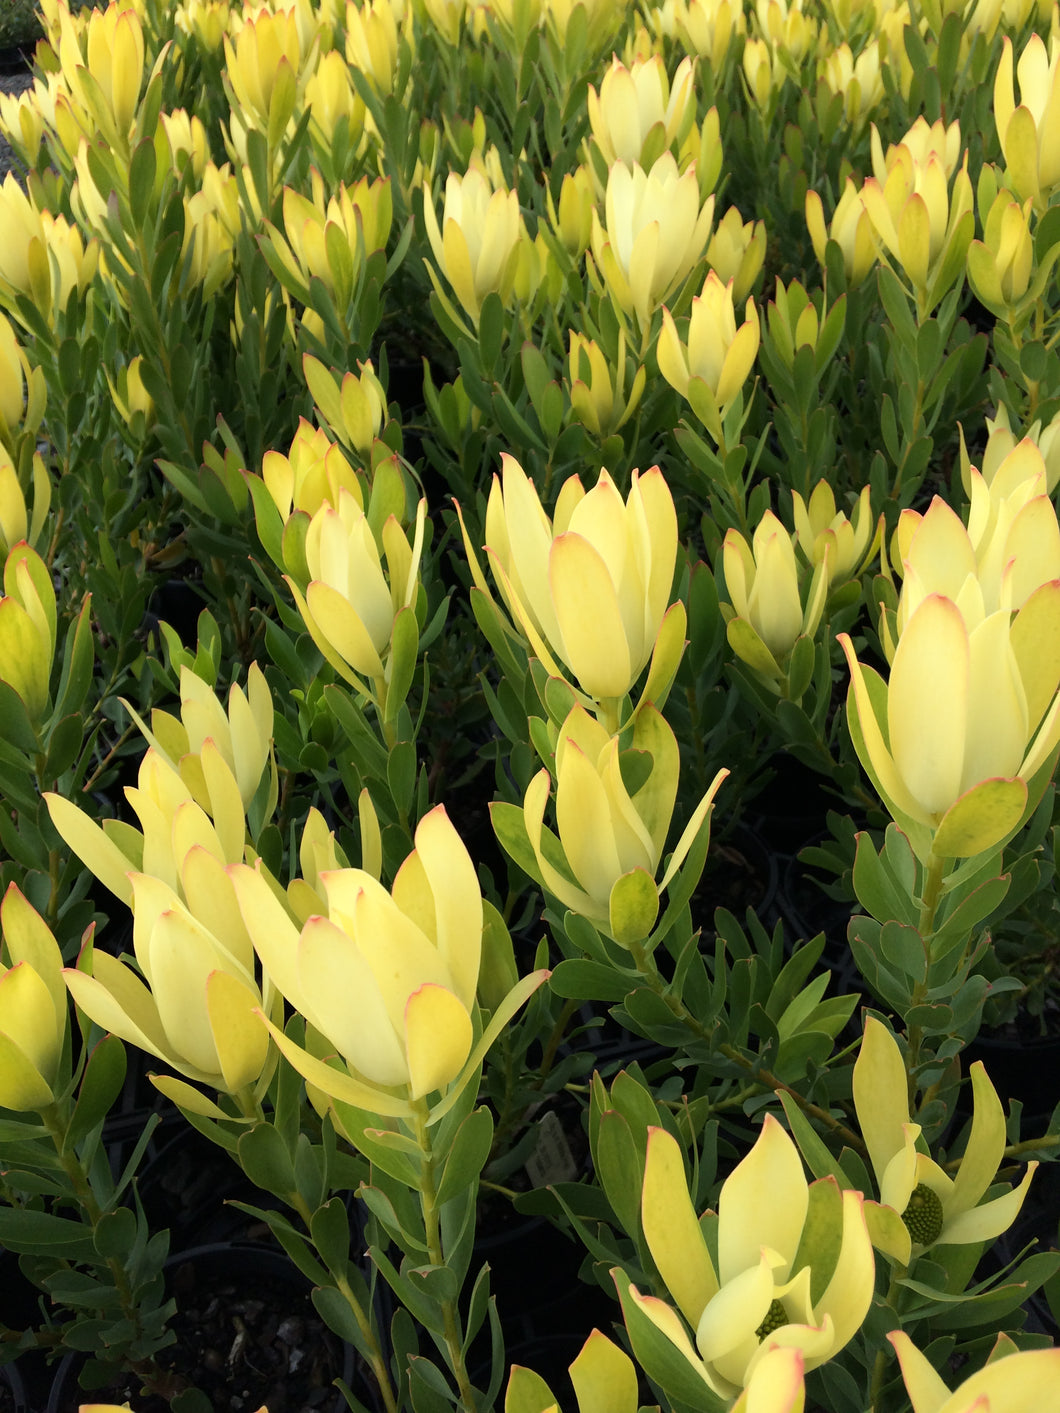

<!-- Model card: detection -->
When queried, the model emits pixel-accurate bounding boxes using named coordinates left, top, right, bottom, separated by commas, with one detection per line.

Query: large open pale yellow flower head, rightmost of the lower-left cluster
left=230, top=805, right=494, bottom=1115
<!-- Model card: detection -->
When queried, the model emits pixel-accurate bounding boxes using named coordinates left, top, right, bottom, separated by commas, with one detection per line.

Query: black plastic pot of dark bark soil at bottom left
left=45, top=1243, right=361, bottom=1413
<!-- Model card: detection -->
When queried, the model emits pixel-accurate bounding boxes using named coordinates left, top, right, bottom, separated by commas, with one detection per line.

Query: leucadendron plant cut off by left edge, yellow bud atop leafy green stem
left=0, top=883, right=174, bottom=1396
